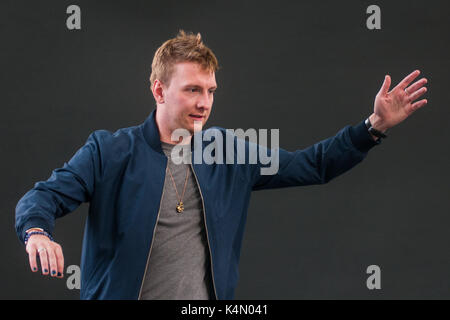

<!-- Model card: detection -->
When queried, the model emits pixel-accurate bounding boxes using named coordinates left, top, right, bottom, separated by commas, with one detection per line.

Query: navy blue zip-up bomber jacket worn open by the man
left=16, top=110, right=380, bottom=299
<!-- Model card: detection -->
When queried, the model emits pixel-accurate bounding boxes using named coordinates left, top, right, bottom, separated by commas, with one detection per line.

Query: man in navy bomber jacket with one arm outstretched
left=16, top=31, right=427, bottom=299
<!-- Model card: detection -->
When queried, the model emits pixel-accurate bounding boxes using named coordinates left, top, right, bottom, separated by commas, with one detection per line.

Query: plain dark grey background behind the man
left=0, top=0, right=450, bottom=299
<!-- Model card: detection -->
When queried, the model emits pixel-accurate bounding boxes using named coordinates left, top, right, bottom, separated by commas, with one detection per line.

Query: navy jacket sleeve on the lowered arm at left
left=16, top=132, right=101, bottom=242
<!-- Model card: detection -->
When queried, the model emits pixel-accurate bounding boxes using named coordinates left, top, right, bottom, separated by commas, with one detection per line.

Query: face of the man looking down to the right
left=158, top=62, right=217, bottom=134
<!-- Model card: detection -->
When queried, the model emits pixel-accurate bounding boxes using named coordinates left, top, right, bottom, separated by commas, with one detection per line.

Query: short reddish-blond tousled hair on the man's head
left=150, top=30, right=219, bottom=86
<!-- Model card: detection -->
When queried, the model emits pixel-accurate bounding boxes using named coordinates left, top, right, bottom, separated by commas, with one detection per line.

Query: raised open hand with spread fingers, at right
left=369, top=70, right=428, bottom=132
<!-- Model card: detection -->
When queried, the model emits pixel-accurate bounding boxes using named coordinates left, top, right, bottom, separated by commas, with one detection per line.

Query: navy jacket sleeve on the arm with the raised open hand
left=252, top=121, right=381, bottom=190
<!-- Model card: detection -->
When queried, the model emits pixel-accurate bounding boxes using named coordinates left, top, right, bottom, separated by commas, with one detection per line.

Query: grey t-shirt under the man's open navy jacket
left=141, top=142, right=214, bottom=300
